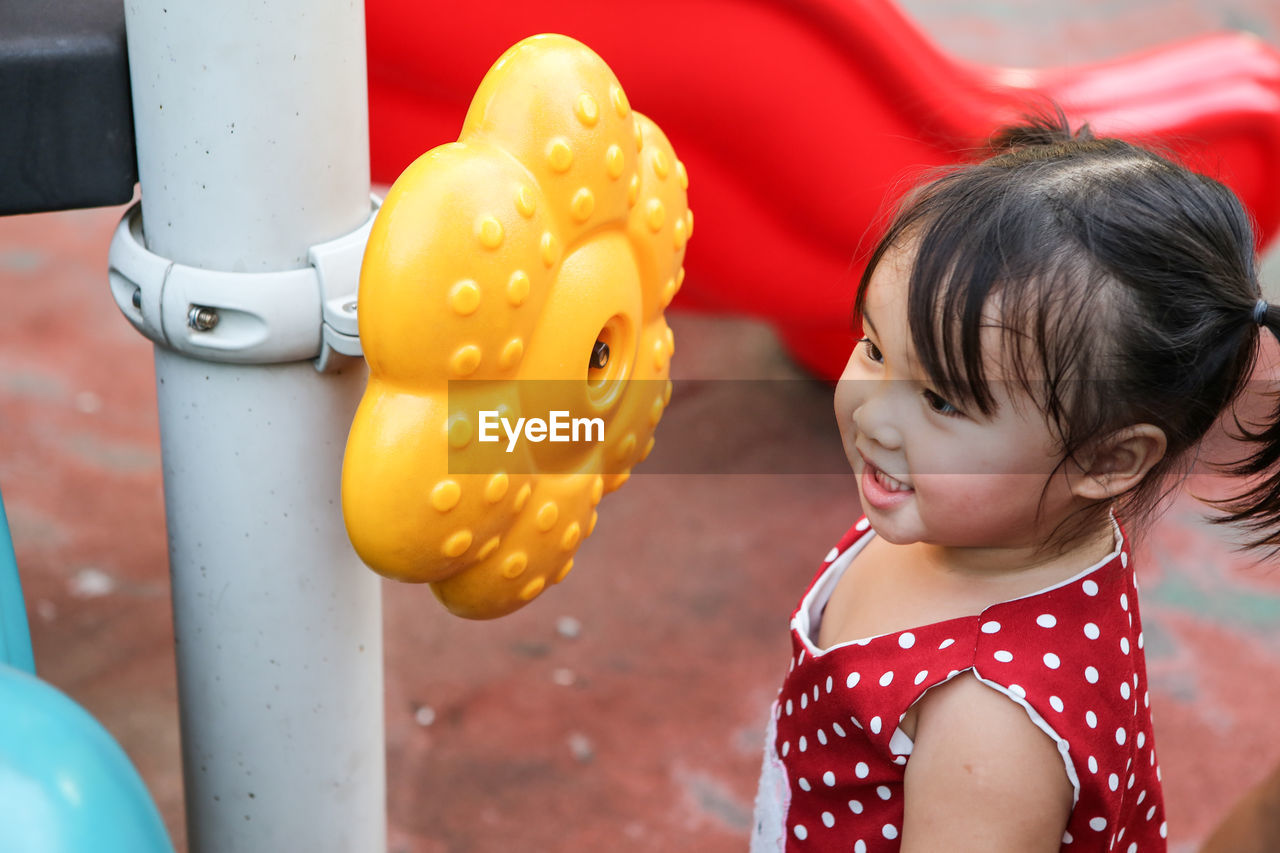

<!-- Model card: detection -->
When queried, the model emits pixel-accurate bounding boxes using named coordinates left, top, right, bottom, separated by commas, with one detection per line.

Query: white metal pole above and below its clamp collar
left=125, top=0, right=387, bottom=853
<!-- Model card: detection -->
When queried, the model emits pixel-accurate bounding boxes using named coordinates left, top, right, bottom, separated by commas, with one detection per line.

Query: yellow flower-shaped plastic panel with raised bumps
left=342, top=35, right=694, bottom=619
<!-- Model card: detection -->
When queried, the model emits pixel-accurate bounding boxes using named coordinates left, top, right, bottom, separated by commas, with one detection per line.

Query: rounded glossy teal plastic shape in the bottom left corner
left=0, top=665, right=173, bottom=853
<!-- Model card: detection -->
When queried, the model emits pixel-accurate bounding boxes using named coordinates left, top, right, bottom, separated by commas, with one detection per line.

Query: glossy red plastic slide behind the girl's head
left=366, top=0, right=1280, bottom=378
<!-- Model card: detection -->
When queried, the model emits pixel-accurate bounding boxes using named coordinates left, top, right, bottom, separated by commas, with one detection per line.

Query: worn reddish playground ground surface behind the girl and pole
left=0, top=0, right=1280, bottom=853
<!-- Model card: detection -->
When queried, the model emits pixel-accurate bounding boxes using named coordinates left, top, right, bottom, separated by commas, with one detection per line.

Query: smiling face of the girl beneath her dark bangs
left=836, top=246, right=1079, bottom=548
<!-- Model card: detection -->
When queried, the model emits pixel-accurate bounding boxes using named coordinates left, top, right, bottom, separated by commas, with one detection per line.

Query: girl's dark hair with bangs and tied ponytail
left=856, top=110, right=1280, bottom=548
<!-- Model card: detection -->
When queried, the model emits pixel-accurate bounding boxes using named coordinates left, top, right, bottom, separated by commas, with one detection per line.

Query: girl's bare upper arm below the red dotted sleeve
left=902, top=672, right=1073, bottom=853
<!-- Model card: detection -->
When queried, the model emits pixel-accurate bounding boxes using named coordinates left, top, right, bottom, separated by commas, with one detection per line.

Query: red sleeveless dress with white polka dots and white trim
left=751, top=519, right=1166, bottom=853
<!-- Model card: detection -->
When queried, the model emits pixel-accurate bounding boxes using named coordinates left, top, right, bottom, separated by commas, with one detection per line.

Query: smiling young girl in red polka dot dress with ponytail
left=751, top=115, right=1280, bottom=853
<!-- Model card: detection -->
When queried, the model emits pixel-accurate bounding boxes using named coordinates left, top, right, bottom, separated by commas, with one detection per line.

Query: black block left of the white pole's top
left=0, top=0, right=138, bottom=214
